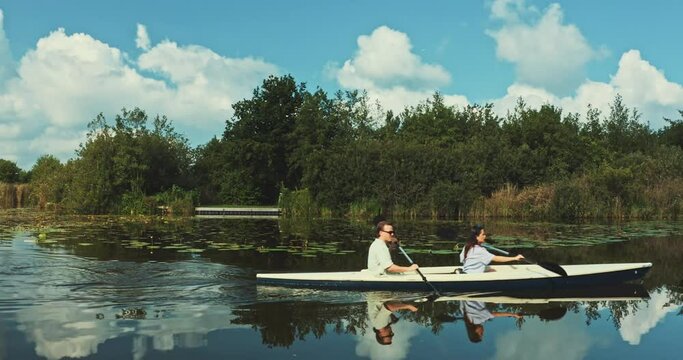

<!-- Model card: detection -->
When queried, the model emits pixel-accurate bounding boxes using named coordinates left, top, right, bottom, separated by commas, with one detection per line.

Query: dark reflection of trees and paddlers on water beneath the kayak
left=231, top=285, right=668, bottom=347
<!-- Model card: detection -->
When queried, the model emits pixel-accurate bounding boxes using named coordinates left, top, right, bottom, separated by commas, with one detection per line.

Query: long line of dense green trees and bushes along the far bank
left=0, top=75, right=683, bottom=219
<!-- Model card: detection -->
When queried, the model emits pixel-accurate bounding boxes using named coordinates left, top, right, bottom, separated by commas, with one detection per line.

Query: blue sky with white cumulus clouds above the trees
left=0, top=0, right=683, bottom=170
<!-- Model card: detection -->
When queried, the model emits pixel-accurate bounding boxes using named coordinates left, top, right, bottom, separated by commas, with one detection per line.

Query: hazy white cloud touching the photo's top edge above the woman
left=487, top=0, right=599, bottom=94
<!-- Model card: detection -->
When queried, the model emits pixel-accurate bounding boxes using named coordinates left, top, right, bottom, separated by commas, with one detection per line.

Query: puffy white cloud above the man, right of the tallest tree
left=328, top=26, right=467, bottom=112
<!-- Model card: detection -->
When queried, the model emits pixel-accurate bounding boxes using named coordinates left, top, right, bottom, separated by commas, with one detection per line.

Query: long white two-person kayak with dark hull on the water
left=256, top=262, right=652, bottom=292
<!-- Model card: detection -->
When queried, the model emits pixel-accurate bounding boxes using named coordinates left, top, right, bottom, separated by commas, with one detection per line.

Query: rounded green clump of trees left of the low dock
left=56, top=108, right=192, bottom=214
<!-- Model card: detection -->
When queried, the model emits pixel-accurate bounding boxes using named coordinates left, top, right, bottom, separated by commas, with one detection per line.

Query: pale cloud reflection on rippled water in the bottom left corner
left=16, top=302, right=243, bottom=359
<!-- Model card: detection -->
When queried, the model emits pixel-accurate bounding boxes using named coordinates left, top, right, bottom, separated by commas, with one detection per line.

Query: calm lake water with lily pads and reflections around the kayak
left=0, top=212, right=683, bottom=359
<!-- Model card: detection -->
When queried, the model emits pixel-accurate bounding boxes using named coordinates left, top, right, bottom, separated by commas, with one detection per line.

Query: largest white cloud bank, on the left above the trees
left=0, top=20, right=279, bottom=168
